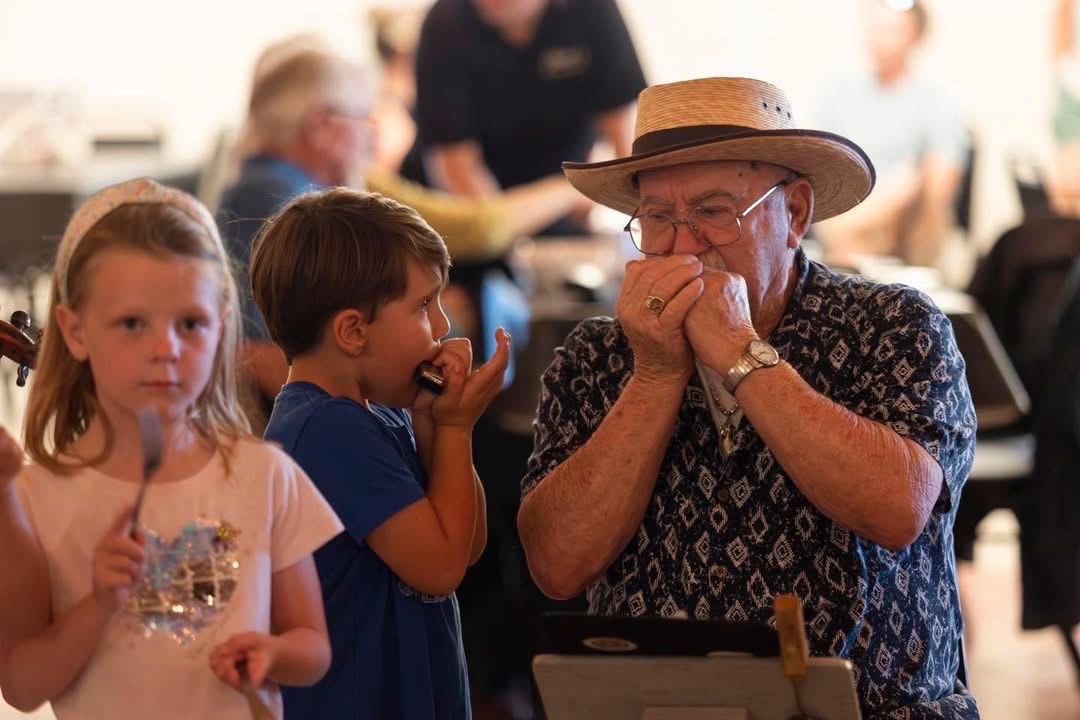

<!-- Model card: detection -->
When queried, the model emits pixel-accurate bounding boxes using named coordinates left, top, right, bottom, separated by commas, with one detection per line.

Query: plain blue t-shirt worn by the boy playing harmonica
left=266, top=382, right=471, bottom=720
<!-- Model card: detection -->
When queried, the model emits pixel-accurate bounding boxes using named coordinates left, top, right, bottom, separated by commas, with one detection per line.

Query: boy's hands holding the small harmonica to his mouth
left=431, top=327, right=510, bottom=429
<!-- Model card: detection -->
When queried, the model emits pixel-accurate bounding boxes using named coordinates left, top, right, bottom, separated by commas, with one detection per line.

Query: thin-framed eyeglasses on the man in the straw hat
left=623, top=178, right=791, bottom=255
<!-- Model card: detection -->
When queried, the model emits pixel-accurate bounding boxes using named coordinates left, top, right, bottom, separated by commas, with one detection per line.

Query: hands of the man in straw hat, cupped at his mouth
left=616, top=255, right=757, bottom=382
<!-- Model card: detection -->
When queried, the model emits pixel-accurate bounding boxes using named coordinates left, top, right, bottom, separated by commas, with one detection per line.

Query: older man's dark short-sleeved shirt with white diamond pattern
left=522, top=252, right=978, bottom=720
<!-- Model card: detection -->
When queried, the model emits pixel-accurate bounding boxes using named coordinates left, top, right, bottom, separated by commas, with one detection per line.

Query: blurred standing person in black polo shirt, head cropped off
left=417, top=0, right=645, bottom=235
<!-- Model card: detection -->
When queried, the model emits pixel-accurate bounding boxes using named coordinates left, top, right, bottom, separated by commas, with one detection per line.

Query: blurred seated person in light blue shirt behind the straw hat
left=813, top=0, right=968, bottom=266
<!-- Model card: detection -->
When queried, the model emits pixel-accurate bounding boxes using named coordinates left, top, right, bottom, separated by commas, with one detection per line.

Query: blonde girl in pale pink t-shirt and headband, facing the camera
left=0, top=179, right=341, bottom=720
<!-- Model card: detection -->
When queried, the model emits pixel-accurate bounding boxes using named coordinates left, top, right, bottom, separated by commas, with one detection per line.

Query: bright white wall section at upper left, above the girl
left=0, top=0, right=382, bottom=158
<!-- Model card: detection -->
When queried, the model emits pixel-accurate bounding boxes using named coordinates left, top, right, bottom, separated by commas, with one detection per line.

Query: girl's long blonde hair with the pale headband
left=24, top=179, right=249, bottom=473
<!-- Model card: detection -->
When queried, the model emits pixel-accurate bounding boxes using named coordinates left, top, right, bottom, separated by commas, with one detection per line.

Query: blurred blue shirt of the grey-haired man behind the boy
left=217, top=155, right=323, bottom=340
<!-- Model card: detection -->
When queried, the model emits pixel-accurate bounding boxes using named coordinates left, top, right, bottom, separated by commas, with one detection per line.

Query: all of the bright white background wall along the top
left=0, top=0, right=1050, bottom=248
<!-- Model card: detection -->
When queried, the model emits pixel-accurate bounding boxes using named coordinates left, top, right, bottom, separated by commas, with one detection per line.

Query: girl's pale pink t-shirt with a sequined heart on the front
left=17, top=438, right=342, bottom=720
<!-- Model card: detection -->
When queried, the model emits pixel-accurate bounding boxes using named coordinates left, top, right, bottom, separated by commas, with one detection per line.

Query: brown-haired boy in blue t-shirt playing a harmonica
left=251, top=188, right=510, bottom=720
